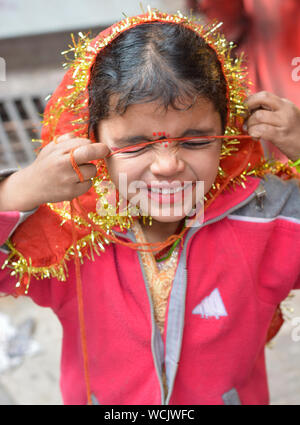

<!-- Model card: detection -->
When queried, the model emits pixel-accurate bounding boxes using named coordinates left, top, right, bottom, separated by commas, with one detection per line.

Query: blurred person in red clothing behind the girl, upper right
left=187, top=0, right=300, bottom=159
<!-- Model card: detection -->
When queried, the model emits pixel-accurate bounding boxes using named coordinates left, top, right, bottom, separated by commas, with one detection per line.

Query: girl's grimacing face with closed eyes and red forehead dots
left=98, top=97, right=222, bottom=223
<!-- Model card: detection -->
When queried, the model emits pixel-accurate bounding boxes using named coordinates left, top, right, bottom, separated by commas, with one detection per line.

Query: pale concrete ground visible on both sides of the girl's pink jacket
left=0, top=291, right=300, bottom=405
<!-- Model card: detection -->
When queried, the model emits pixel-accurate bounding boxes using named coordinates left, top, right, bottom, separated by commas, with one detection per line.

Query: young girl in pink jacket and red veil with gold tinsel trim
left=0, top=10, right=300, bottom=405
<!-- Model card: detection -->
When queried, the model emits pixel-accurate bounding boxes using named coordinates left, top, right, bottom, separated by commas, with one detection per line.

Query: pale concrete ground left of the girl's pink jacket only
left=0, top=297, right=62, bottom=405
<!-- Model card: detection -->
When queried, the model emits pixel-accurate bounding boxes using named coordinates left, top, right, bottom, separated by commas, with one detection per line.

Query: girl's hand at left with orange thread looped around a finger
left=0, top=134, right=110, bottom=211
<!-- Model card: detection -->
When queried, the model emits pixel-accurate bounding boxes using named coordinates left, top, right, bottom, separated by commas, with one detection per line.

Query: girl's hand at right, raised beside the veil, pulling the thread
left=245, top=91, right=300, bottom=161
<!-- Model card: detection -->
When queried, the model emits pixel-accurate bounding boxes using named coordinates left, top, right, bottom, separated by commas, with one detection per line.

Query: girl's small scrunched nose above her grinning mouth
left=150, top=146, right=184, bottom=177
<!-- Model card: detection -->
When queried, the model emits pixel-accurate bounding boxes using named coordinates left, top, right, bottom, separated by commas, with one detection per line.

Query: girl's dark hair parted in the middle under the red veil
left=88, top=22, right=228, bottom=138
